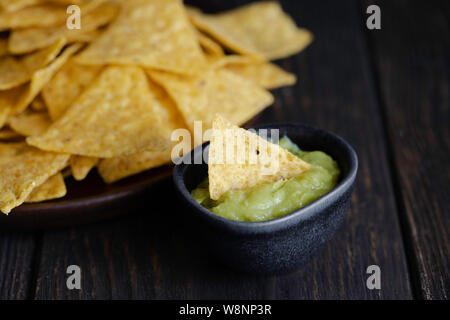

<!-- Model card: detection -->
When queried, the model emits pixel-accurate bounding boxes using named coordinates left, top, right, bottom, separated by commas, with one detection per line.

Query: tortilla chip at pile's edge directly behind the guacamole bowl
left=147, top=69, right=273, bottom=130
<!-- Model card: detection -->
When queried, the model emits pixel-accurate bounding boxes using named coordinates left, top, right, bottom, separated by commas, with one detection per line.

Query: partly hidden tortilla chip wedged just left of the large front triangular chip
left=42, top=58, right=101, bottom=120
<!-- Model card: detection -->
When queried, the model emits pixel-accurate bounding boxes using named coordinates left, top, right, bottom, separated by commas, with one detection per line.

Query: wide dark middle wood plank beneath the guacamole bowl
left=35, top=1, right=411, bottom=299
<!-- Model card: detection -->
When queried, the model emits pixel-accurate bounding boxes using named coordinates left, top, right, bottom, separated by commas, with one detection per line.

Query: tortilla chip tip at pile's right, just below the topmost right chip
left=225, top=58, right=297, bottom=89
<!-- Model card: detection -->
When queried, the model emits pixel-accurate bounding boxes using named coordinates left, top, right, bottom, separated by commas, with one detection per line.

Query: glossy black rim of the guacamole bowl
left=173, top=122, right=358, bottom=234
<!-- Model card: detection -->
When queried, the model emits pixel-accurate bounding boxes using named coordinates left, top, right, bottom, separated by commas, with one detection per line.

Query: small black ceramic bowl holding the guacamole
left=173, top=123, right=358, bottom=274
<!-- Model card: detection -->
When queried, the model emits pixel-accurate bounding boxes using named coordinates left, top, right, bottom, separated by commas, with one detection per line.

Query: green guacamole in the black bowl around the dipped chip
left=191, top=137, right=339, bottom=221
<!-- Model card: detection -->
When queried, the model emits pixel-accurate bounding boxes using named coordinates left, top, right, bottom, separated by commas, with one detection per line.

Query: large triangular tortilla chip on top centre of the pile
left=78, top=0, right=205, bottom=74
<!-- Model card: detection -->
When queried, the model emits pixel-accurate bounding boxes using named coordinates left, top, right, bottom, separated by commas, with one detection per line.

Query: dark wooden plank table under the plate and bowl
left=0, top=0, right=450, bottom=299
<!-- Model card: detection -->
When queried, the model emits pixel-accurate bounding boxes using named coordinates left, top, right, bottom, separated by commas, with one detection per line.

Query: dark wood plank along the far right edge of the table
left=366, top=1, right=450, bottom=299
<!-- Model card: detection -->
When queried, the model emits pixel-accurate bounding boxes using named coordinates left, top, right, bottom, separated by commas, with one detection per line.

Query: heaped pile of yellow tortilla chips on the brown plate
left=0, top=0, right=312, bottom=214
